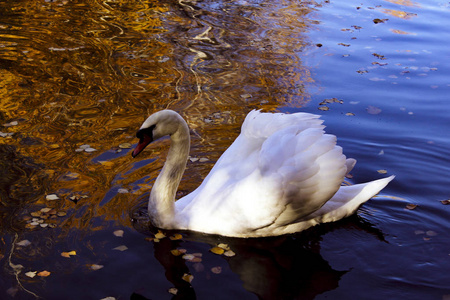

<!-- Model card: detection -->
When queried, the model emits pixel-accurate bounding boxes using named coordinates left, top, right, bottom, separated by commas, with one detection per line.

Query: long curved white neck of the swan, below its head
left=148, top=120, right=190, bottom=229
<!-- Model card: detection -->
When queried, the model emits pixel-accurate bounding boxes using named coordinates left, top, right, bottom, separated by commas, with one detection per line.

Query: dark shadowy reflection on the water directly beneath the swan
left=134, top=212, right=385, bottom=299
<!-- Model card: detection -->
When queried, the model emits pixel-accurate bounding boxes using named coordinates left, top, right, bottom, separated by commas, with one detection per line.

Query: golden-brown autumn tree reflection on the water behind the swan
left=0, top=0, right=317, bottom=236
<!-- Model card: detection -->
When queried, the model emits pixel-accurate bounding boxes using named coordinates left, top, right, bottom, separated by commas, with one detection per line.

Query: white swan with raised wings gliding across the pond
left=132, top=110, right=394, bottom=237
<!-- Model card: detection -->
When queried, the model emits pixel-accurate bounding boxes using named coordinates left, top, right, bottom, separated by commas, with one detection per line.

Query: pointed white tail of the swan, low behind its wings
left=308, top=175, right=395, bottom=223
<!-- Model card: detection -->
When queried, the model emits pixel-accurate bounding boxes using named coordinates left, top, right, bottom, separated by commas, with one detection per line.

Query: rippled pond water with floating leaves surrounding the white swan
left=0, top=0, right=450, bottom=299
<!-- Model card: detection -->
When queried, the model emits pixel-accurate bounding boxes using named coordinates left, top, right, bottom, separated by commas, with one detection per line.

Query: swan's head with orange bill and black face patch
left=131, top=109, right=186, bottom=157
